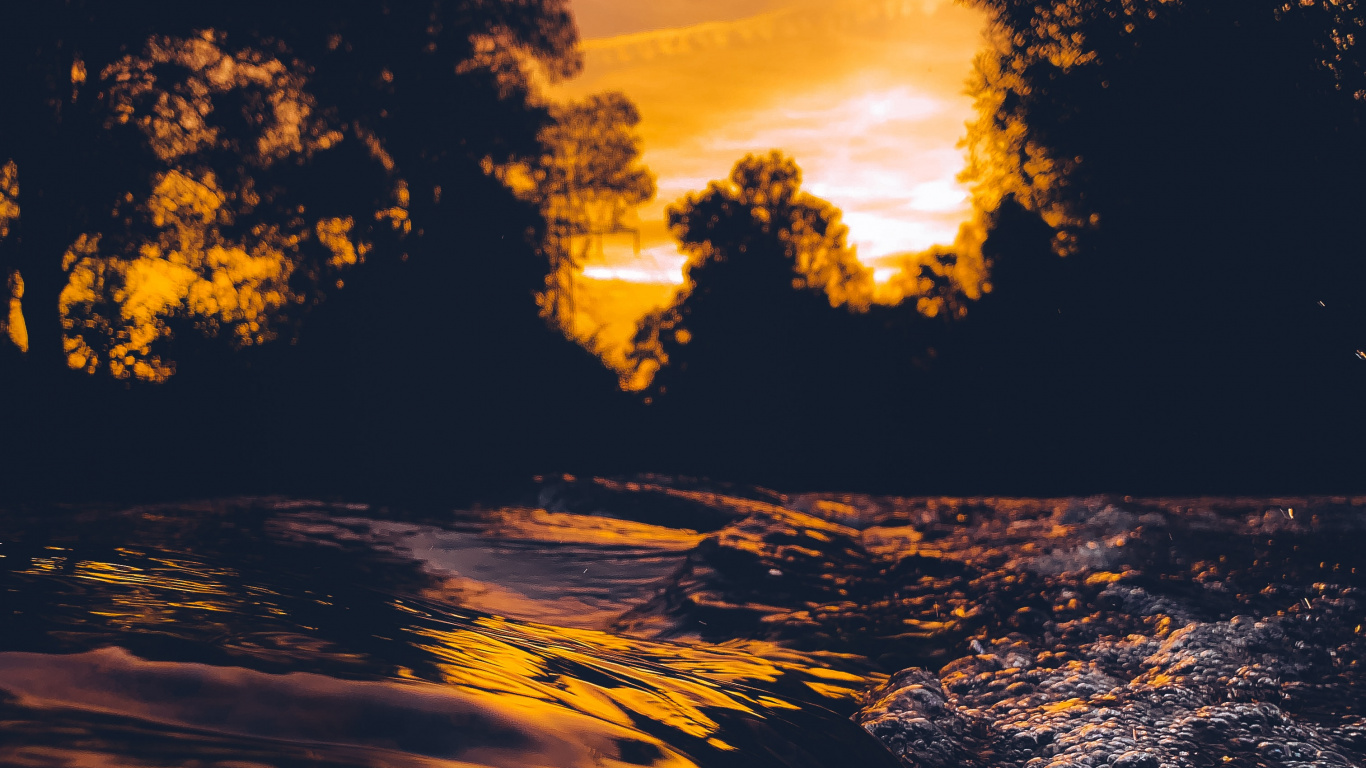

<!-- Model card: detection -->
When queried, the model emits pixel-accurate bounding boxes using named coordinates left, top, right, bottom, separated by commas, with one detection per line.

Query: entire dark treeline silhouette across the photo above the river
left=0, top=0, right=1366, bottom=500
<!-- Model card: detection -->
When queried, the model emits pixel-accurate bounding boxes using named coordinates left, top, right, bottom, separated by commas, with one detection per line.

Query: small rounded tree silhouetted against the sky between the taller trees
left=631, top=152, right=873, bottom=395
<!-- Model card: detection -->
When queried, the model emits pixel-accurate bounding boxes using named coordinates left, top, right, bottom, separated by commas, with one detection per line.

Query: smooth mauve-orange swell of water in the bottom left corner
left=0, top=648, right=695, bottom=768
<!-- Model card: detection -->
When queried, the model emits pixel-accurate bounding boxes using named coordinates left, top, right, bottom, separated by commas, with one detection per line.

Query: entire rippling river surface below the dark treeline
left=0, top=477, right=1366, bottom=768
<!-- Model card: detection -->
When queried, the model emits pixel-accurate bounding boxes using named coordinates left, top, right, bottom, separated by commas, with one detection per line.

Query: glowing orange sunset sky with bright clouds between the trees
left=549, top=0, right=984, bottom=371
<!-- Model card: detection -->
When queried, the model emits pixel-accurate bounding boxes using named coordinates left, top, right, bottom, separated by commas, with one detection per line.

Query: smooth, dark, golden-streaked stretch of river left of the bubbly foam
left=0, top=475, right=895, bottom=768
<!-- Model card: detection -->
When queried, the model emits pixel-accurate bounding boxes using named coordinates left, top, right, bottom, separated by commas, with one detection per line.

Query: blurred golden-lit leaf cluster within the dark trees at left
left=59, top=33, right=398, bottom=381
